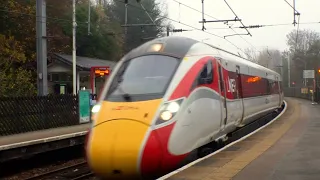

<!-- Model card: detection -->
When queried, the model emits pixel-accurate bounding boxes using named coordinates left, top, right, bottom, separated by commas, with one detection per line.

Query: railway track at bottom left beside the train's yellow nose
left=23, top=161, right=94, bottom=180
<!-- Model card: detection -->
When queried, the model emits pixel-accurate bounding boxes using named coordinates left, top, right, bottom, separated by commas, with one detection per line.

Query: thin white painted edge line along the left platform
left=0, top=131, right=88, bottom=151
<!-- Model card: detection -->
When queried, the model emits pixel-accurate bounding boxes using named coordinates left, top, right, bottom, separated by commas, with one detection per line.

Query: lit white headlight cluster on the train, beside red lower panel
left=156, top=99, right=183, bottom=125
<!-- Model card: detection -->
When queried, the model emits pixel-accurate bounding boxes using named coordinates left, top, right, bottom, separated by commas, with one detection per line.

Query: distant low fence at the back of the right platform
left=283, top=87, right=320, bottom=102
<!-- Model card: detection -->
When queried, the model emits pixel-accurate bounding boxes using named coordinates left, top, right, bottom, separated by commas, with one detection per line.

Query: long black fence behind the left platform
left=0, top=95, right=79, bottom=136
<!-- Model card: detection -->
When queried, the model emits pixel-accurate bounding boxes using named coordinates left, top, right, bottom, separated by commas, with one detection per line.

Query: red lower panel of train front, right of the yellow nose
left=141, top=123, right=188, bottom=174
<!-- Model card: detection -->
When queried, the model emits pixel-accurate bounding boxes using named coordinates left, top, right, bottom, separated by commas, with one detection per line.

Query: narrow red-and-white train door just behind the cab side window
left=217, top=63, right=228, bottom=129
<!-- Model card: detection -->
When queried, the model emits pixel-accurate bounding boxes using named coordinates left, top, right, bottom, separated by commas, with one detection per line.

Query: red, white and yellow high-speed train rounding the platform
left=86, top=37, right=283, bottom=179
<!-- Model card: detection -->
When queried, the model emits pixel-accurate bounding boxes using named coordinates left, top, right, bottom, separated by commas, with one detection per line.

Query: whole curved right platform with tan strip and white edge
left=160, top=98, right=320, bottom=180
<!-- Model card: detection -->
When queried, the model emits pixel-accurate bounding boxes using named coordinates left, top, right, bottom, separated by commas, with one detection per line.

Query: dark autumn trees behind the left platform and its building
left=0, top=0, right=170, bottom=96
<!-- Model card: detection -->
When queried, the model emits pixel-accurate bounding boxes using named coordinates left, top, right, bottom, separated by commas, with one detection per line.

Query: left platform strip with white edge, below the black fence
left=0, top=124, right=90, bottom=151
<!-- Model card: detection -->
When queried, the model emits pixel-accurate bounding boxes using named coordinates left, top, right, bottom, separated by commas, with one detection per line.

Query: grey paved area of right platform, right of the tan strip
left=233, top=98, right=320, bottom=180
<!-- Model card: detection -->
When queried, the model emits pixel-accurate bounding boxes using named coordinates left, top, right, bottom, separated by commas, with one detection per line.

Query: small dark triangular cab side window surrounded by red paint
left=191, top=60, right=213, bottom=89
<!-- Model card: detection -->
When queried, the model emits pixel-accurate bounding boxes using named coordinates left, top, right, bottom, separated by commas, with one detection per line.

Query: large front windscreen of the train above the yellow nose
left=105, top=55, right=180, bottom=102
